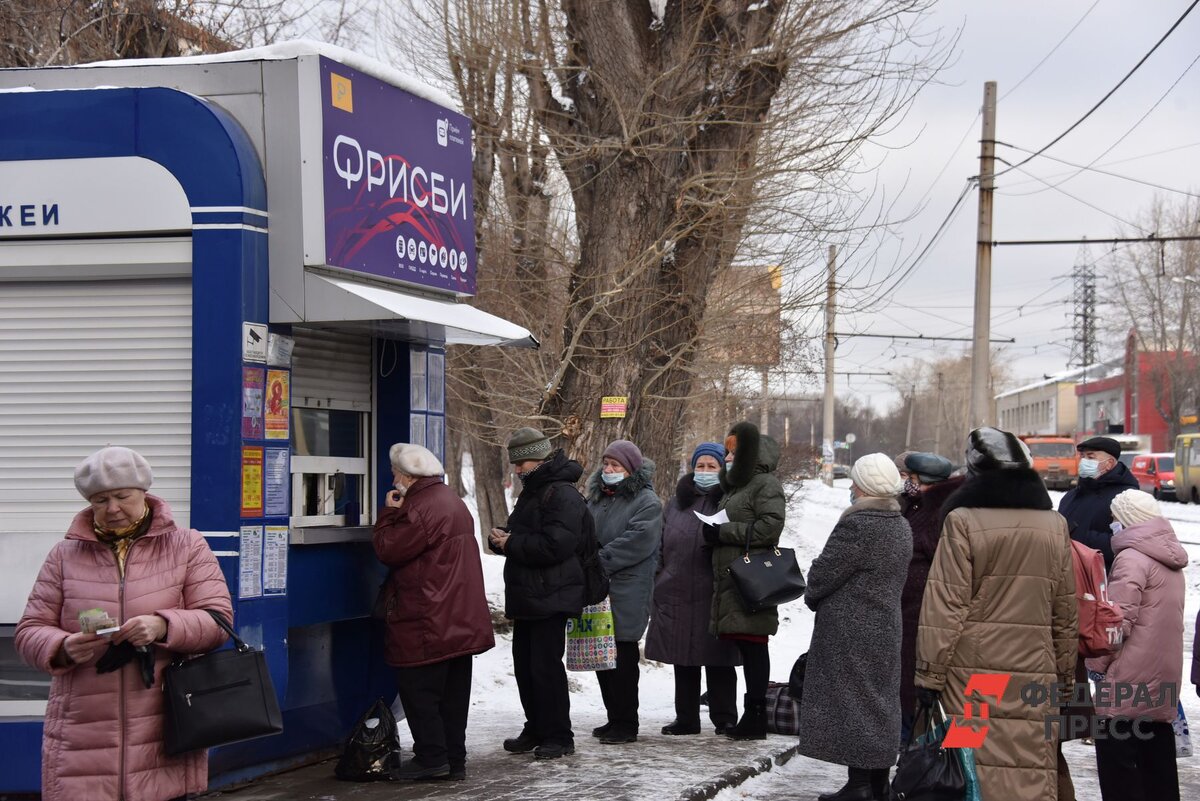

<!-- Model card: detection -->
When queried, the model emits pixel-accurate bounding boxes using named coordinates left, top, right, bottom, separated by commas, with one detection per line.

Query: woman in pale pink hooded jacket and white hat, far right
left=1087, top=489, right=1188, bottom=801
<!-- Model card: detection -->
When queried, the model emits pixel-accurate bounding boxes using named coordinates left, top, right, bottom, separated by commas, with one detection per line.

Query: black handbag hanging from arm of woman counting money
left=162, top=609, right=283, bottom=755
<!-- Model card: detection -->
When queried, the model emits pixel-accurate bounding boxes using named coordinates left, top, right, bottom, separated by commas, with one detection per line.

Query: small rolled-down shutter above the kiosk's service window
left=292, top=326, right=371, bottom=411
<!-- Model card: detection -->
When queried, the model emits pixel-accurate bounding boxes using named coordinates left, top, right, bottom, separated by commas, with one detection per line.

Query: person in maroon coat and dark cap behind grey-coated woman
left=896, top=452, right=966, bottom=742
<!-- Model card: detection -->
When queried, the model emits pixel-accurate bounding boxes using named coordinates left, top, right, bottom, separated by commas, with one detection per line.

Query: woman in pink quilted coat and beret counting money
left=16, top=447, right=233, bottom=801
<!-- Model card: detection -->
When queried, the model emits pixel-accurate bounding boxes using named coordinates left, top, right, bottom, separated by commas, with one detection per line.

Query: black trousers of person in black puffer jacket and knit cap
left=512, top=615, right=575, bottom=746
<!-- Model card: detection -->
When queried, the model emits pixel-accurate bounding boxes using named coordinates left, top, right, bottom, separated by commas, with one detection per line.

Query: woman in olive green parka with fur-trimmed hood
left=704, top=422, right=786, bottom=740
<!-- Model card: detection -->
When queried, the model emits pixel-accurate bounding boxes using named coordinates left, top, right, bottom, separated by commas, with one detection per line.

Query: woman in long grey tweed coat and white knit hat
left=799, top=453, right=912, bottom=801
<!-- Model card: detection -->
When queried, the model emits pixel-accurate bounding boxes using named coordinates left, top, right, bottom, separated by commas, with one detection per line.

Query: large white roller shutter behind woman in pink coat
left=0, top=278, right=192, bottom=622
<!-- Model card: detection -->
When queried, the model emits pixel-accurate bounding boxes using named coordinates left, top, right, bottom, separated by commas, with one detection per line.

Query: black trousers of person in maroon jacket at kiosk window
left=396, top=655, right=472, bottom=767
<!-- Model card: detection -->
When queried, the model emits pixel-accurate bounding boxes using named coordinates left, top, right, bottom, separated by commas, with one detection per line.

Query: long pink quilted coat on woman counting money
left=16, top=495, right=233, bottom=801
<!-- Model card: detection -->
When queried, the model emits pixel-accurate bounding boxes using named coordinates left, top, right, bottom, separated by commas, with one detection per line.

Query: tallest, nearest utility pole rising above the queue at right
left=968, top=80, right=996, bottom=428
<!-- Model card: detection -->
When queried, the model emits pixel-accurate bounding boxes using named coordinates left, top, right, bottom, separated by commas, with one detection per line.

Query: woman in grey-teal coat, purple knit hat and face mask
left=588, top=439, right=662, bottom=745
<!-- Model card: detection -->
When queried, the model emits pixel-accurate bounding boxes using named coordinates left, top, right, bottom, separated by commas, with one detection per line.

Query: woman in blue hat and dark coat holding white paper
left=646, top=442, right=742, bottom=734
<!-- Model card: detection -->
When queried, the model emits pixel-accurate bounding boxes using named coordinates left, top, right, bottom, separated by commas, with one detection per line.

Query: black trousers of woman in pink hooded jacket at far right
left=1096, top=718, right=1180, bottom=801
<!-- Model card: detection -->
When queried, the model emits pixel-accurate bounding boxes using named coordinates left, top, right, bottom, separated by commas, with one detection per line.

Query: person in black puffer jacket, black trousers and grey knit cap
left=488, top=428, right=588, bottom=759
